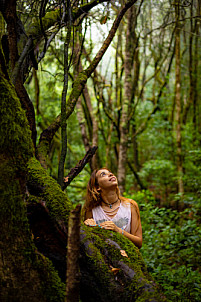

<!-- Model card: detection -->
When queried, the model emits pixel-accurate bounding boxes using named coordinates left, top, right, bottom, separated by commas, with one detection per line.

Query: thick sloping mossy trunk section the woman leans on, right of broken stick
left=80, top=226, right=165, bottom=302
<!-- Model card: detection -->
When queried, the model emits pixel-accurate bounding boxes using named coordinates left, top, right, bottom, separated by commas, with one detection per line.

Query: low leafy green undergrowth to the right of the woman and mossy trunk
left=125, top=191, right=201, bottom=302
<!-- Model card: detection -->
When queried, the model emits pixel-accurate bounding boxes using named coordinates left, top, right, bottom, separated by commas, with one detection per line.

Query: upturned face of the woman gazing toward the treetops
left=96, top=169, right=118, bottom=189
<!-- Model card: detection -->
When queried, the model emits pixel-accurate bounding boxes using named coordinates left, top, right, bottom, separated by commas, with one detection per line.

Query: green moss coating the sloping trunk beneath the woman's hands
left=82, top=226, right=164, bottom=302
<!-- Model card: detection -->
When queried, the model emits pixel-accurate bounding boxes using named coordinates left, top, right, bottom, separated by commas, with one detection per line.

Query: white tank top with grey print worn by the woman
left=92, top=202, right=131, bottom=233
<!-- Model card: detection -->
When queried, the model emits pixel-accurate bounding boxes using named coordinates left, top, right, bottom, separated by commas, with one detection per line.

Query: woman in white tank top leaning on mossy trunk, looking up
left=83, top=168, right=142, bottom=248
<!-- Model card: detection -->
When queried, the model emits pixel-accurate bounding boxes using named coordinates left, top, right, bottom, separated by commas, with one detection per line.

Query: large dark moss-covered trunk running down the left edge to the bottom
left=0, top=74, right=65, bottom=302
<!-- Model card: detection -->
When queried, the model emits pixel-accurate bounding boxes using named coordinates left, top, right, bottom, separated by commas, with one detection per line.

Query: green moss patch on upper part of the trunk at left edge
left=0, top=70, right=33, bottom=163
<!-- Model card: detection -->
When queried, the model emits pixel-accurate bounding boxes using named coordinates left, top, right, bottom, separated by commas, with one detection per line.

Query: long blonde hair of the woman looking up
left=82, top=168, right=140, bottom=230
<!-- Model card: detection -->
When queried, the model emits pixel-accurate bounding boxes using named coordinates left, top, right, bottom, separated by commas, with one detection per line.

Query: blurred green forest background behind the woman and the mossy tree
left=0, top=0, right=201, bottom=302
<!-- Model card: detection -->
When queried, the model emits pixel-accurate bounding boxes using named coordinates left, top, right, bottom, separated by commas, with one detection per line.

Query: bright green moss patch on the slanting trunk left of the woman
left=28, top=157, right=72, bottom=225
